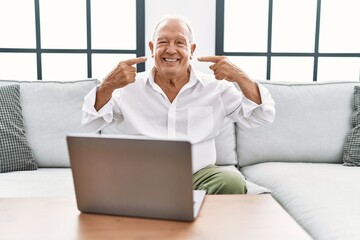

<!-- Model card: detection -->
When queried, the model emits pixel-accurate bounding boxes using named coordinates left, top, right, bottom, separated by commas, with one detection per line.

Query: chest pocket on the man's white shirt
left=187, top=107, right=214, bottom=137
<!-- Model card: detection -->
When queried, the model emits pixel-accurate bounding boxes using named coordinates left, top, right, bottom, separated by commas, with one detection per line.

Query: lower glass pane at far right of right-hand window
left=317, top=57, right=360, bottom=81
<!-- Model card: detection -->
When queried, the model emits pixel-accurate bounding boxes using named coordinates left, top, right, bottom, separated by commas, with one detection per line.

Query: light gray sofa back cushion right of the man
left=236, top=81, right=360, bottom=166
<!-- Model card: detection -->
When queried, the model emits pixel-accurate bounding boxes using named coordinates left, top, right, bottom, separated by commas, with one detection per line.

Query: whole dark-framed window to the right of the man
left=215, top=0, right=360, bottom=82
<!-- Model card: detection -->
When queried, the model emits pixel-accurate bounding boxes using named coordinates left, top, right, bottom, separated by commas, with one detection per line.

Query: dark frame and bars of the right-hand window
left=215, top=0, right=360, bottom=82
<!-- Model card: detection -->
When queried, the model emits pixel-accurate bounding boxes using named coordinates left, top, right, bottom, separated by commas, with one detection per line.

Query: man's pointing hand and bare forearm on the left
left=94, top=57, right=147, bottom=111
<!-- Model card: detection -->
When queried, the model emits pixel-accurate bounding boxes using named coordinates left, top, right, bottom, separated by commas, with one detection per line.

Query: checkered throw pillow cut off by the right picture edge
left=343, top=86, right=360, bottom=166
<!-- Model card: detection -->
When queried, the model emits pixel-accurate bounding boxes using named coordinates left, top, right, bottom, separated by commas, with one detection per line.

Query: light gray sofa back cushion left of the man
left=0, top=79, right=99, bottom=167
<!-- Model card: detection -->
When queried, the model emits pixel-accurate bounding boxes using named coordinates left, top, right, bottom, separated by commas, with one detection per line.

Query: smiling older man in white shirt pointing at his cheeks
left=82, top=16, right=275, bottom=194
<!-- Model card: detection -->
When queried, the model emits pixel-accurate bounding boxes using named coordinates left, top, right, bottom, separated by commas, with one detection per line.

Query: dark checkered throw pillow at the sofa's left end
left=0, top=85, right=37, bottom=173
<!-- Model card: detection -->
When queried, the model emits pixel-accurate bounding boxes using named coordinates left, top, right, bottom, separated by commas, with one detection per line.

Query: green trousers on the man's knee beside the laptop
left=193, top=165, right=247, bottom=194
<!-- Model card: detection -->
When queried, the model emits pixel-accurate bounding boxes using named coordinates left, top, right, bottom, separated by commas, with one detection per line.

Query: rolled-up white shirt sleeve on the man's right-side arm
left=224, top=83, right=275, bottom=127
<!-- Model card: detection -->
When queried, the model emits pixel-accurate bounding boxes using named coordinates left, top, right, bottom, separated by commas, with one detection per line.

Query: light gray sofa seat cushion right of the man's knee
left=241, top=162, right=360, bottom=240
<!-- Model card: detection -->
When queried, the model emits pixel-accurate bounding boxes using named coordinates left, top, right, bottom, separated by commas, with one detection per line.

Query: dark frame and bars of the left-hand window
left=0, top=0, right=145, bottom=80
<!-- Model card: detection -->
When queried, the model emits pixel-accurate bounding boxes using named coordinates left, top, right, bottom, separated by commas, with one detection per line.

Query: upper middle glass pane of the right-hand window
left=272, top=0, right=316, bottom=52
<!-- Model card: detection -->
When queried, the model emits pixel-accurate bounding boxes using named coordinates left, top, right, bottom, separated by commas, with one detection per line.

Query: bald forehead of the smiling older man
left=155, top=20, right=189, bottom=39
